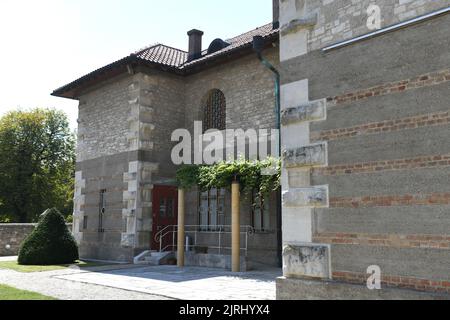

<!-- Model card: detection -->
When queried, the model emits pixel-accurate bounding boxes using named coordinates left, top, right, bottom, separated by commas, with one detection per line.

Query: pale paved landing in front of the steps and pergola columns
left=57, top=266, right=281, bottom=300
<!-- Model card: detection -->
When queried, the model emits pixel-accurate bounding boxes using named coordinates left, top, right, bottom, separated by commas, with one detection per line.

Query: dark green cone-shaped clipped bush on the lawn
left=18, top=209, right=79, bottom=265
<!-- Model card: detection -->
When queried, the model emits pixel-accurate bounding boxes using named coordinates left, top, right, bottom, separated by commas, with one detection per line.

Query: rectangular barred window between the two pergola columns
left=198, top=189, right=225, bottom=231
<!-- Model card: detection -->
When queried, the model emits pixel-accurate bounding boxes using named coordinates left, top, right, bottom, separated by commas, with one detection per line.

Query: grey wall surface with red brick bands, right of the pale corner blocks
left=309, top=16, right=450, bottom=293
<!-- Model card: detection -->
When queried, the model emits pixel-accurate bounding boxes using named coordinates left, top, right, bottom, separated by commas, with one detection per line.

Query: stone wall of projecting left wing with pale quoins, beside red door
left=74, top=69, right=184, bottom=261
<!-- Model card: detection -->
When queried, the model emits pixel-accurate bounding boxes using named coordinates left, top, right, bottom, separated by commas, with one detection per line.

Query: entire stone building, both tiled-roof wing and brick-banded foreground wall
left=54, top=0, right=450, bottom=299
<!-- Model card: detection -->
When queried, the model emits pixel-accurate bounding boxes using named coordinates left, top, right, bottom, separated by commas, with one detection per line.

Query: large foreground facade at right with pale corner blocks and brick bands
left=277, top=0, right=450, bottom=299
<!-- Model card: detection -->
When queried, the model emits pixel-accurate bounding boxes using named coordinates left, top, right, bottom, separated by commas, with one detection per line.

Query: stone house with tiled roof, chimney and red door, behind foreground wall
left=53, top=23, right=281, bottom=267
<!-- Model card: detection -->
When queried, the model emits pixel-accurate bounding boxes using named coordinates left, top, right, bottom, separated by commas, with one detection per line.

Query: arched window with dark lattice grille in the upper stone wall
left=203, top=89, right=226, bottom=131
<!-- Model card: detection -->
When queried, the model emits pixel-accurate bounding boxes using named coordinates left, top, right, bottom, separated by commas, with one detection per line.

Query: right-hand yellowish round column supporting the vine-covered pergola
left=231, top=181, right=241, bottom=272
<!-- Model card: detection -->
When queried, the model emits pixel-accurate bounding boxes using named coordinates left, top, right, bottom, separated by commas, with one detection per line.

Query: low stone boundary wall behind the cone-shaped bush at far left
left=0, top=223, right=72, bottom=257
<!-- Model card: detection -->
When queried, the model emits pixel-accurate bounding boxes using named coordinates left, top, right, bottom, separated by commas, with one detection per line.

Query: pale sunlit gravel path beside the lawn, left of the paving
left=0, top=269, right=172, bottom=300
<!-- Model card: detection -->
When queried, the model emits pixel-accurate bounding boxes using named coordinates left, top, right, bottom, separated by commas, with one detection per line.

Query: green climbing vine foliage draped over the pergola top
left=177, top=158, right=281, bottom=195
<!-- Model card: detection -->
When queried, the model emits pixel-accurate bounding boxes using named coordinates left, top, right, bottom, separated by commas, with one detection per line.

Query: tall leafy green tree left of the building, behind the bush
left=0, top=109, right=75, bottom=223
